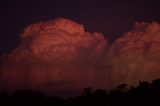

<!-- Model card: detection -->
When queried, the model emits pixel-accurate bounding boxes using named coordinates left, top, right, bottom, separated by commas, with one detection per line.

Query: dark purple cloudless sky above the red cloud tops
left=0, top=0, right=160, bottom=55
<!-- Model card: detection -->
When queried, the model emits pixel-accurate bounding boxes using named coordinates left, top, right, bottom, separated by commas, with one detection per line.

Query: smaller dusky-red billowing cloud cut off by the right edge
left=109, top=22, right=160, bottom=84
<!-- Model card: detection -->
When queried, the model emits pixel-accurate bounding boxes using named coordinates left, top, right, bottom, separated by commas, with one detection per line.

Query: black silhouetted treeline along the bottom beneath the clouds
left=0, top=79, right=160, bottom=106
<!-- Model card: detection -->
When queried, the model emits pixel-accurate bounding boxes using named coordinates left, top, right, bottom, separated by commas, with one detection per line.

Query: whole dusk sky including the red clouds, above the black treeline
left=0, top=0, right=160, bottom=96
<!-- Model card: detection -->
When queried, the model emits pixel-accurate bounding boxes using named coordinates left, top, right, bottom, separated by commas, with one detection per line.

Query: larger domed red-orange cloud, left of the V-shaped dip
left=1, top=18, right=108, bottom=94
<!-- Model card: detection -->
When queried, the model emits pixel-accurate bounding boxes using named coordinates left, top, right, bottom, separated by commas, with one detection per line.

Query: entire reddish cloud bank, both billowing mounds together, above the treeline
left=0, top=18, right=160, bottom=97
